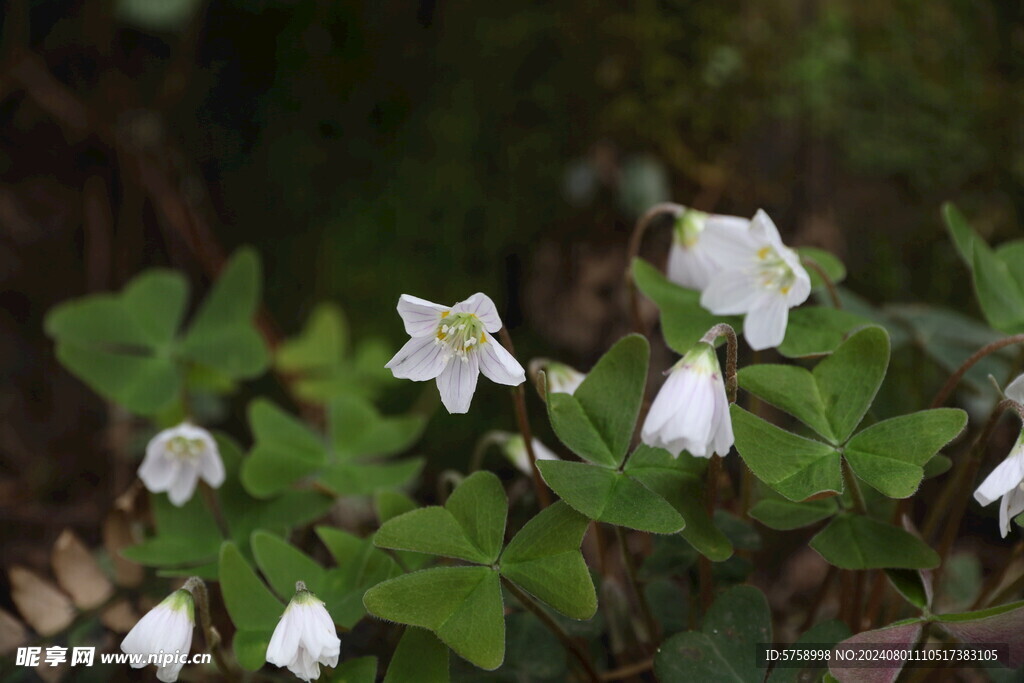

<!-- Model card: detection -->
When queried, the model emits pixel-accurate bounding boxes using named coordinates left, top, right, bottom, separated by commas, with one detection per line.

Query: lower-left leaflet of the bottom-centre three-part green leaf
left=362, top=566, right=505, bottom=671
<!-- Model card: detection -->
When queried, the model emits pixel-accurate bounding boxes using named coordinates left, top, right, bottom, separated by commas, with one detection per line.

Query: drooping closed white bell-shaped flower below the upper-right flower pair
left=640, top=342, right=733, bottom=458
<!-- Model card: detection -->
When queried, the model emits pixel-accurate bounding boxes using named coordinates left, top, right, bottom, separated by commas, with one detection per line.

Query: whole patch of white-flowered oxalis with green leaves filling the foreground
left=11, top=204, right=1024, bottom=682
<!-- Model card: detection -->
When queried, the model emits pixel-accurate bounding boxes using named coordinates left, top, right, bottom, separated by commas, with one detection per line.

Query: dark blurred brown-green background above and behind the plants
left=0, top=0, right=1024, bottom=589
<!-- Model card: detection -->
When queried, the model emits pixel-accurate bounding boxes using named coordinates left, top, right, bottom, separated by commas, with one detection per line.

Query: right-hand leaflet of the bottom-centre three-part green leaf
left=501, top=501, right=597, bottom=620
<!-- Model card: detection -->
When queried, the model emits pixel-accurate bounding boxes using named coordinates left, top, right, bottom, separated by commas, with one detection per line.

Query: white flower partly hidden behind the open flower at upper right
left=669, top=209, right=751, bottom=290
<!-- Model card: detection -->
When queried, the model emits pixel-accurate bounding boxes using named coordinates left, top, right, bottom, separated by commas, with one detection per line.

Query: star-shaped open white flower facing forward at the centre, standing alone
left=385, top=293, right=526, bottom=413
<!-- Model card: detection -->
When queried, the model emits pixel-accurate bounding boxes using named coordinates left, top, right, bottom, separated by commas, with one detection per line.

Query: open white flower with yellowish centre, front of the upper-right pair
left=700, top=211, right=811, bottom=350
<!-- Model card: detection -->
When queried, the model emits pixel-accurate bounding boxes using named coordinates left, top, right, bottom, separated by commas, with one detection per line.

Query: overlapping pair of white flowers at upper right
left=669, top=209, right=811, bottom=350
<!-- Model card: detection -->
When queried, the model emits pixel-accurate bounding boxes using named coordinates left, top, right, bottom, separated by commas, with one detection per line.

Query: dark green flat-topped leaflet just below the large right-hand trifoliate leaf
left=810, top=514, right=939, bottom=569
